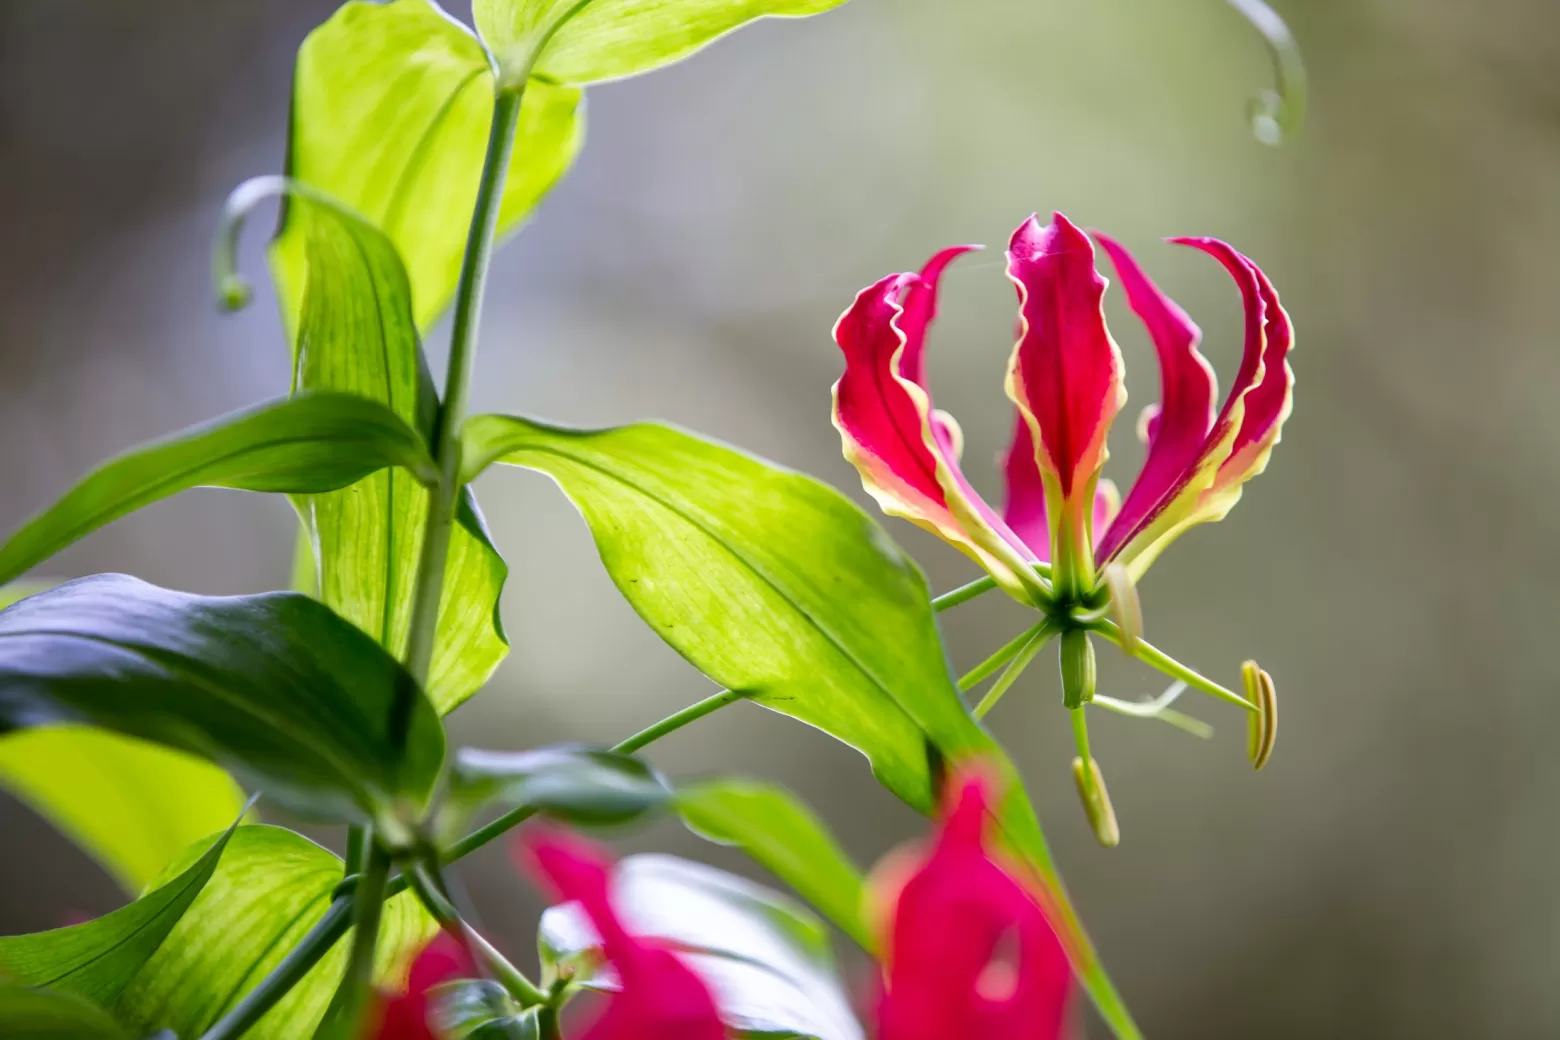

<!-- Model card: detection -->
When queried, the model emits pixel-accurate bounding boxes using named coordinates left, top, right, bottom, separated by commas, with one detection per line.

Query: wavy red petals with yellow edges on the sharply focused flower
left=835, top=214, right=1293, bottom=608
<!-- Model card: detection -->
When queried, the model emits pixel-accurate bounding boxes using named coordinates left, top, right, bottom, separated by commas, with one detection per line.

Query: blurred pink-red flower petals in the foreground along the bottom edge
left=373, top=769, right=1072, bottom=1040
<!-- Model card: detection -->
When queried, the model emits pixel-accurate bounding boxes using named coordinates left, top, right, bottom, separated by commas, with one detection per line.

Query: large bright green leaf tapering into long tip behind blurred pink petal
left=462, top=415, right=1139, bottom=1038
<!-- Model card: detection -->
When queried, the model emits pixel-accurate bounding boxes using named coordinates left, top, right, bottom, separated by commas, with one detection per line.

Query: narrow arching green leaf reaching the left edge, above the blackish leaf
left=0, top=393, right=437, bottom=582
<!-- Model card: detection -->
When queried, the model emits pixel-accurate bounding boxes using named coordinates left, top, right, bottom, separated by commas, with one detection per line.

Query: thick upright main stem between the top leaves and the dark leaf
left=406, top=81, right=526, bottom=681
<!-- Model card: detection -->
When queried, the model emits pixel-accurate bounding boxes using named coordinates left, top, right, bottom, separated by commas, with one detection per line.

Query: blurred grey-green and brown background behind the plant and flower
left=0, top=0, right=1560, bottom=1038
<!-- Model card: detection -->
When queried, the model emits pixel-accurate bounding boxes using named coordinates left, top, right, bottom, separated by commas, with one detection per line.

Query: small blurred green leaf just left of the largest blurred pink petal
left=677, top=780, right=877, bottom=953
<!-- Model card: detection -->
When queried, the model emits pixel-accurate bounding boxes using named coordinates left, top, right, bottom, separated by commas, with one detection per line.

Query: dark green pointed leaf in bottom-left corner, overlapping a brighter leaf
left=0, top=806, right=242, bottom=1010
